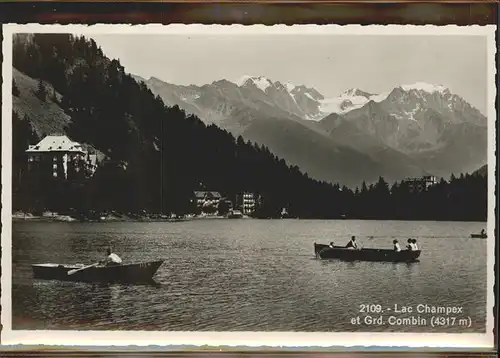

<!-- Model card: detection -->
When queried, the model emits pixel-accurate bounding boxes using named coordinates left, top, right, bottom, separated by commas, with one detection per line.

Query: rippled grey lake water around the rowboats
left=12, top=219, right=487, bottom=332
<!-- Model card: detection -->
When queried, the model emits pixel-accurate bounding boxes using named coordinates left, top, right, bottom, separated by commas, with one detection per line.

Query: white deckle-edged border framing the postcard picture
left=1, top=24, right=496, bottom=349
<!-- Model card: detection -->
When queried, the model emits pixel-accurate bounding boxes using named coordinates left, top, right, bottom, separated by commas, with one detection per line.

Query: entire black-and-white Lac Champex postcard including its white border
left=1, top=24, right=496, bottom=347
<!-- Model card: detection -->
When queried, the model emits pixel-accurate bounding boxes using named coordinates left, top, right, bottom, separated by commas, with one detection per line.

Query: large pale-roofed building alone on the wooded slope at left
left=26, top=135, right=97, bottom=180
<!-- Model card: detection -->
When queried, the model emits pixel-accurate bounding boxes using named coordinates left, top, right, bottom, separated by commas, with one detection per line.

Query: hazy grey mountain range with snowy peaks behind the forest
left=134, top=76, right=487, bottom=186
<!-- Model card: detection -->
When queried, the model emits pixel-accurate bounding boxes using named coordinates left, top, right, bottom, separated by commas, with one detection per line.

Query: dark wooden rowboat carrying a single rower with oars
left=31, top=260, right=164, bottom=283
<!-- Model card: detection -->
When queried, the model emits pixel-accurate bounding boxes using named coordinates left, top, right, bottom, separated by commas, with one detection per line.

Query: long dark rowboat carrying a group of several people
left=314, top=243, right=421, bottom=262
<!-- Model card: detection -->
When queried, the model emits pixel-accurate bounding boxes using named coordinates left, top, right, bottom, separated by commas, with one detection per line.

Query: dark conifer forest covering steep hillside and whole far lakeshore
left=13, top=34, right=486, bottom=220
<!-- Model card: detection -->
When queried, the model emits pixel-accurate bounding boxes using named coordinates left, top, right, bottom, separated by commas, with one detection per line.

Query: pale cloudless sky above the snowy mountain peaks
left=90, top=34, right=487, bottom=113
